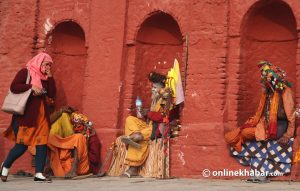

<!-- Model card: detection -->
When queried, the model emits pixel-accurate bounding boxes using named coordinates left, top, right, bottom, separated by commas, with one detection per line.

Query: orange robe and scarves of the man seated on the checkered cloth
left=225, top=87, right=295, bottom=152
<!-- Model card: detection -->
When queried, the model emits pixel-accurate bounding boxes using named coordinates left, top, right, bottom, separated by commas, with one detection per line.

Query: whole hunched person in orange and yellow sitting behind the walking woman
left=48, top=107, right=100, bottom=178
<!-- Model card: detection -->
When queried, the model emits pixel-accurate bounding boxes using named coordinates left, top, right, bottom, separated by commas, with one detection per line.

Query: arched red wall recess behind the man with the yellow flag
left=133, top=12, right=184, bottom=107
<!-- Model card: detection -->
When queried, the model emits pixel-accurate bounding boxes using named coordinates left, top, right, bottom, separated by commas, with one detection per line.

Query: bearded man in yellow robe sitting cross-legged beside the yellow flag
left=121, top=72, right=174, bottom=177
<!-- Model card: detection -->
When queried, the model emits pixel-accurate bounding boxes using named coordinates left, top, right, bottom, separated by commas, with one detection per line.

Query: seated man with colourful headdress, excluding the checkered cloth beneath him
left=225, top=61, right=295, bottom=152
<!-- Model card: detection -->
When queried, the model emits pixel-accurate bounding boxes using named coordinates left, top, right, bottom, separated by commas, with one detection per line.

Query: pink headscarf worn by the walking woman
left=26, top=53, right=53, bottom=88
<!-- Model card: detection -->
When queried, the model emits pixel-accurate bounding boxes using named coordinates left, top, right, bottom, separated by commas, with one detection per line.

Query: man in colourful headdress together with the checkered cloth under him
left=225, top=61, right=296, bottom=181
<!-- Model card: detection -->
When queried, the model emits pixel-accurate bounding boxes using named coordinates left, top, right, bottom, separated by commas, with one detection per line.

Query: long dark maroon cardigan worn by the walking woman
left=10, top=68, right=56, bottom=127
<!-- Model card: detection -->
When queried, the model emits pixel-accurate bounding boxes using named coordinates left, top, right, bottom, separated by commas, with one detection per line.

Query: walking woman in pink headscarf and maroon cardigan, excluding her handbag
left=1, top=53, right=56, bottom=182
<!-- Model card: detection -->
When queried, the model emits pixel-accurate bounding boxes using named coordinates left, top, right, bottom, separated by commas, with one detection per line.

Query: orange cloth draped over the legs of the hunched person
left=48, top=134, right=89, bottom=177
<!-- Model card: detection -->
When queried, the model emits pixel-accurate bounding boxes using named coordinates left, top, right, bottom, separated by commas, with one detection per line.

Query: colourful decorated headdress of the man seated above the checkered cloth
left=258, top=60, right=292, bottom=91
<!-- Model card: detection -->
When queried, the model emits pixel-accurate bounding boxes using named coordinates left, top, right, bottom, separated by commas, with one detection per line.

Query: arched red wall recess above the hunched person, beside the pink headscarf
left=47, top=21, right=87, bottom=110
